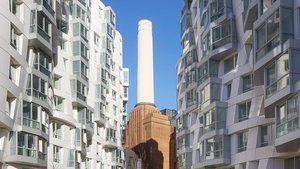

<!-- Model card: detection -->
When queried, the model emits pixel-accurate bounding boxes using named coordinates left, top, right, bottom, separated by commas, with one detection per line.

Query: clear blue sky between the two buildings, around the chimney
left=102, top=0, right=183, bottom=115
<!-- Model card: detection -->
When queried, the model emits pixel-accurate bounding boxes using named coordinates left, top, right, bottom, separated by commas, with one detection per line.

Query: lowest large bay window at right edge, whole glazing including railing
left=276, top=95, right=299, bottom=138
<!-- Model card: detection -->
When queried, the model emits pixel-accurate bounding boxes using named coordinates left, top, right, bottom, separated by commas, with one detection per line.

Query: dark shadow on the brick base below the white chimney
left=133, top=139, right=164, bottom=169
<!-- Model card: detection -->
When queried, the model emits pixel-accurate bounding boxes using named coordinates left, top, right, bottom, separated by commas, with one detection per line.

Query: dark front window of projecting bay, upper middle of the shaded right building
left=212, top=20, right=231, bottom=49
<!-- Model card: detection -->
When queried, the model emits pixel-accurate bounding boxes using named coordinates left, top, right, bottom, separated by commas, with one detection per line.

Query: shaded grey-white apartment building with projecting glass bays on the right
left=176, top=0, right=300, bottom=169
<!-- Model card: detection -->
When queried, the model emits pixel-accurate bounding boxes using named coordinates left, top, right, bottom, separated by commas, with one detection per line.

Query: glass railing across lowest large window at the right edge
left=276, top=116, right=299, bottom=138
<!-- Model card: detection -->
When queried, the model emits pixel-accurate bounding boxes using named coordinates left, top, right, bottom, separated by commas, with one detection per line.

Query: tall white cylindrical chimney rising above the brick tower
left=137, top=20, right=154, bottom=104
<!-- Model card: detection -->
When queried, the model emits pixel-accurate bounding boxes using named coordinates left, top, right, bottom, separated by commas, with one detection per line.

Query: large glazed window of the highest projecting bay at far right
left=256, top=9, right=280, bottom=62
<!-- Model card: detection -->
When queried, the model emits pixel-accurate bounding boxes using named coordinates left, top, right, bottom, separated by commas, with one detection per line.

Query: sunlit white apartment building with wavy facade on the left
left=0, top=0, right=129, bottom=169
